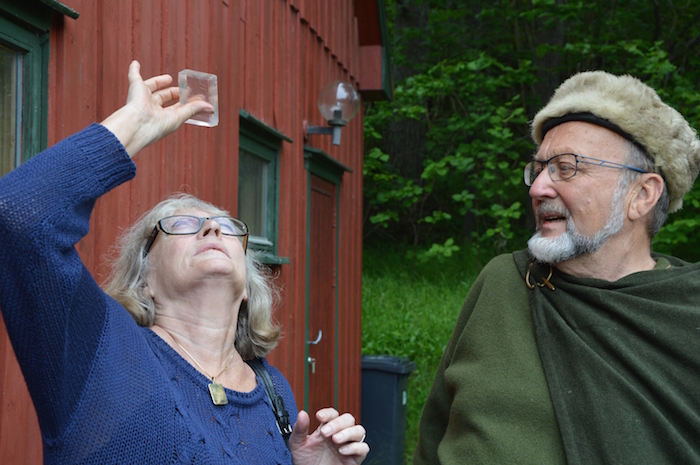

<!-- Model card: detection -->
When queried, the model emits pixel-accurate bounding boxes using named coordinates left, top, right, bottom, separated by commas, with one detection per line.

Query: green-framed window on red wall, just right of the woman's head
left=238, top=110, right=292, bottom=265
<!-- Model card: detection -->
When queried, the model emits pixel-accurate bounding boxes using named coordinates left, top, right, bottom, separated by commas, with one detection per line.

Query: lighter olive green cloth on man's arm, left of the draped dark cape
left=413, top=254, right=566, bottom=465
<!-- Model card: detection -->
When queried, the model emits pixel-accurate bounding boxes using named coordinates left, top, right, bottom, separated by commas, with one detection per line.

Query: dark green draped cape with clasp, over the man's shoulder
left=513, top=251, right=700, bottom=465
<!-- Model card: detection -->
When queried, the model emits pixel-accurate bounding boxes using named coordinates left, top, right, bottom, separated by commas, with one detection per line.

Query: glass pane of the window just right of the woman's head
left=238, top=149, right=270, bottom=239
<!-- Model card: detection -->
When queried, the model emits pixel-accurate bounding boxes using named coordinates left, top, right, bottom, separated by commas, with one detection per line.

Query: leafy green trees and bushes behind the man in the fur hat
left=364, top=0, right=700, bottom=260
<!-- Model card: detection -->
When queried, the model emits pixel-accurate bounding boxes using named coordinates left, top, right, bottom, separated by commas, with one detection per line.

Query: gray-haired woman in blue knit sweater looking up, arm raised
left=0, top=62, right=369, bottom=464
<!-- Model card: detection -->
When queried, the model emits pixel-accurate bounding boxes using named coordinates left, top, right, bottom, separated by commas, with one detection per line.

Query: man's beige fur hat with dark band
left=532, top=71, right=700, bottom=213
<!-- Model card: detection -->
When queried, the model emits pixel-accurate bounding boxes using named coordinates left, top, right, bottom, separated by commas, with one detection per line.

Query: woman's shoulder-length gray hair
left=105, top=194, right=281, bottom=360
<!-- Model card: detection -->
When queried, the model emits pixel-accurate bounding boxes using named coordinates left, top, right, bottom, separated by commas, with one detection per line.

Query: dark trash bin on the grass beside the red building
left=362, top=355, right=416, bottom=465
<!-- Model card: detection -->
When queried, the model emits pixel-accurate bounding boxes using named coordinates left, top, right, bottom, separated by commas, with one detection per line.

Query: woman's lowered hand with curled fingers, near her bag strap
left=289, top=408, right=369, bottom=465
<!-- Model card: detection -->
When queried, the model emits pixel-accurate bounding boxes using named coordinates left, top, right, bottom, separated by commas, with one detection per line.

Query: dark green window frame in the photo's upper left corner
left=0, top=0, right=78, bottom=174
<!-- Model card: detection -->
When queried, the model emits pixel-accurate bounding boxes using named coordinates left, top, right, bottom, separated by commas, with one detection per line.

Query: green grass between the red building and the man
left=362, top=247, right=477, bottom=464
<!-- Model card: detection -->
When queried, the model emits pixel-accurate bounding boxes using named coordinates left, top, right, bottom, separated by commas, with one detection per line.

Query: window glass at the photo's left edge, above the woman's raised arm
left=0, top=45, right=22, bottom=176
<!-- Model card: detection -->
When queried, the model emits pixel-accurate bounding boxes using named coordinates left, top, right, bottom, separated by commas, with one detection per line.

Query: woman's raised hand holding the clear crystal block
left=102, top=60, right=214, bottom=157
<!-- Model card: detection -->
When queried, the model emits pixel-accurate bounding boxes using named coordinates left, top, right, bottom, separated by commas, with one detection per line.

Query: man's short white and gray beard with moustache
left=527, top=179, right=629, bottom=264
